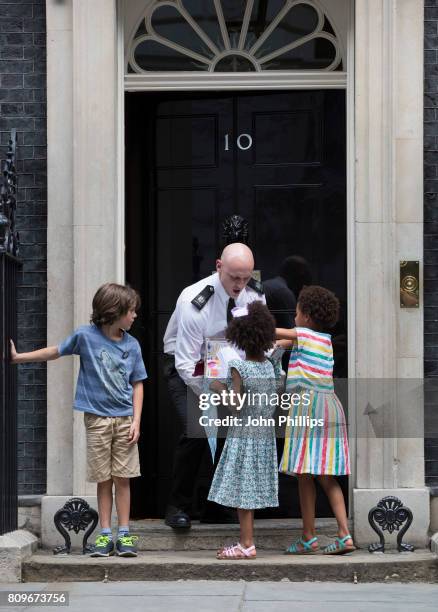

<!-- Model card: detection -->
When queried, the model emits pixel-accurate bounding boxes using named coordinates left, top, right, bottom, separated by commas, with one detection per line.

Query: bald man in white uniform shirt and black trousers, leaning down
left=164, top=243, right=265, bottom=529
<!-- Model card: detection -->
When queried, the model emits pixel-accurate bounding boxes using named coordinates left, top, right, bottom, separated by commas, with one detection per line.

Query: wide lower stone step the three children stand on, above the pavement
left=22, top=550, right=438, bottom=583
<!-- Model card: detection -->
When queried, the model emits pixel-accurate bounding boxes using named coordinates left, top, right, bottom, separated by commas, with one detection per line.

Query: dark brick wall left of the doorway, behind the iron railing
left=0, top=0, right=47, bottom=494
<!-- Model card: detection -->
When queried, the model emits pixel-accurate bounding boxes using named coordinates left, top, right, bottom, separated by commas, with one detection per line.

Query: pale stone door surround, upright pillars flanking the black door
left=42, top=0, right=429, bottom=547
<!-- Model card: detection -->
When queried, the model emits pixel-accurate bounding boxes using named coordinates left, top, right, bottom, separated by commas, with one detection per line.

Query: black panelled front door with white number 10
left=126, top=90, right=347, bottom=517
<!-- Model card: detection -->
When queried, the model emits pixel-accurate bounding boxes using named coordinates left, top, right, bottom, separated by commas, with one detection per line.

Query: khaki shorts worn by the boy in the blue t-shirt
left=84, top=412, right=140, bottom=482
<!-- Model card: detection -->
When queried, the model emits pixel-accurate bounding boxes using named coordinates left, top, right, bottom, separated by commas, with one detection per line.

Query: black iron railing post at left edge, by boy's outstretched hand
left=0, top=130, right=21, bottom=535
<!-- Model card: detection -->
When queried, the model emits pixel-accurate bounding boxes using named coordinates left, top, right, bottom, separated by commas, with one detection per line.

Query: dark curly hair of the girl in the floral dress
left=225, top=300, right=275, bottom=355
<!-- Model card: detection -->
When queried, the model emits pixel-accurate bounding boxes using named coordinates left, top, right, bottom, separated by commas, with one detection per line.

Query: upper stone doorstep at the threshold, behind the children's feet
left=108, top=519, right=344, bottom=552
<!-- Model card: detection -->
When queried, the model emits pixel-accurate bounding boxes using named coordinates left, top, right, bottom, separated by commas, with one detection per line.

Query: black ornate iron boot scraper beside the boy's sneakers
left=53, top=497, right=98, bottom=555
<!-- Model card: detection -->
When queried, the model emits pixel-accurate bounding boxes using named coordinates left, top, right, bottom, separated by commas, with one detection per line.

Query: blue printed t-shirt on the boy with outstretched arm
left=58, top=325, right=147, bottom=417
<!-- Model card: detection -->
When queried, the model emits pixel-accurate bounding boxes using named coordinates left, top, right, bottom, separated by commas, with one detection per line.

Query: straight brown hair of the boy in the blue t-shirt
left=90, top=283, right=141, bottom=327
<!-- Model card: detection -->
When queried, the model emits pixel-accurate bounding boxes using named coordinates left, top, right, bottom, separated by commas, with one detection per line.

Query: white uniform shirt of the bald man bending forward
left=163, top=272, right=266, bottom=393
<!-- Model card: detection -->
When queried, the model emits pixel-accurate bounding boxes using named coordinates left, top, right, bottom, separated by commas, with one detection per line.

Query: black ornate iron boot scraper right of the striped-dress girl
left=368, top=495, right=415, bottom=553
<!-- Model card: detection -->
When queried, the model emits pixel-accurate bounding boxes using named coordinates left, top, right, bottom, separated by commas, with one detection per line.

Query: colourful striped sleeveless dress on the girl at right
left=279, top=327, right=350, bottom=476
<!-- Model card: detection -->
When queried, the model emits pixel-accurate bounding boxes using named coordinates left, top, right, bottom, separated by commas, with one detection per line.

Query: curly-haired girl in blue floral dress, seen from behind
left=208, top=301, right=281, bottom=560
